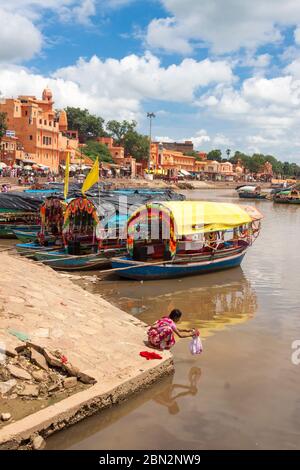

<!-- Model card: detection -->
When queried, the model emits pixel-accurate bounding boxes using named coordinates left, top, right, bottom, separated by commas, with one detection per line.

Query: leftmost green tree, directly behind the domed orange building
left=65, top=106, right=107, bottom=142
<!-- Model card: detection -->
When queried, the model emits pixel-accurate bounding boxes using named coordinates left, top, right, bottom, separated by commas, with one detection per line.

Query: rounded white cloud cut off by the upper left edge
left=0, top=6, right=42, bottom=62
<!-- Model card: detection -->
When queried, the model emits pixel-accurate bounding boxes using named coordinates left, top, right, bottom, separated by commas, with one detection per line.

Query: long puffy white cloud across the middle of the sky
left=54, top=52, right=233, bottom=103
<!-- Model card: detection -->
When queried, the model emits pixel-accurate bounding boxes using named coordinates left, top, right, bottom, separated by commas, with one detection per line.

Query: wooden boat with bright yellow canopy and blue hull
left=112, top=201, right=262, bottom=280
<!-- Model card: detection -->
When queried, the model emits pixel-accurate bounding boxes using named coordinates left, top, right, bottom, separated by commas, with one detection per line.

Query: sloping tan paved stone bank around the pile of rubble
left=0, top=253, right=173, bottom=448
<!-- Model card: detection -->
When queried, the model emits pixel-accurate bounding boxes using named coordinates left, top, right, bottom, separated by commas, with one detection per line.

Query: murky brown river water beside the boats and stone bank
left=48, top=190, right=300, bottom=449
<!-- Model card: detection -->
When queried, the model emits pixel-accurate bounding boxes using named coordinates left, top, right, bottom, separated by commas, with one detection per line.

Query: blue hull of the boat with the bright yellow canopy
left=112, top=251, right=245, bottom=281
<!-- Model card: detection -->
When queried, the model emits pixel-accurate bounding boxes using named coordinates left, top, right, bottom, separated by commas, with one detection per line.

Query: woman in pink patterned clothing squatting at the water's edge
left=148, top=309, right=198, bottom=350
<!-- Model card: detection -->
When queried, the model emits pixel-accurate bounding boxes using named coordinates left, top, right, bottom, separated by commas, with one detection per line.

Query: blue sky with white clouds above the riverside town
left=0, top=0, right=300, bottom=163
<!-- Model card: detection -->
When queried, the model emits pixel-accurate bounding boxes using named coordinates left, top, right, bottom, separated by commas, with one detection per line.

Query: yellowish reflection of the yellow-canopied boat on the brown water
left=96, top=268, right=257, bottom=337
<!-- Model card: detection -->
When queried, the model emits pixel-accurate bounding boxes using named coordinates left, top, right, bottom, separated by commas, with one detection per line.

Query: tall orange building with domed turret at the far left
left=0, top=88, right=78, bottom=171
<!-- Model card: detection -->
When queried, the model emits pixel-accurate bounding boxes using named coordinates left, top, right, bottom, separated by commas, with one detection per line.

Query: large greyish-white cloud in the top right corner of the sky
left=147, top=0, right=300, bottom=54
